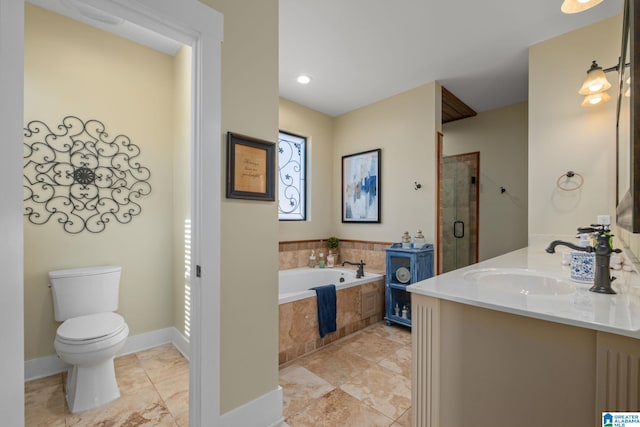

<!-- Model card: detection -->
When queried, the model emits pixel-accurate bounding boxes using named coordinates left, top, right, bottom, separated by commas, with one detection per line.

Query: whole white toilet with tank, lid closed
left=49, top=266, right=129, bottom=413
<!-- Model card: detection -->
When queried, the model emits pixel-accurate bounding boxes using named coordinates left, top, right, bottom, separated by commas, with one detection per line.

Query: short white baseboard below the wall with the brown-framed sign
left=220, top=386, right=284, bottom=427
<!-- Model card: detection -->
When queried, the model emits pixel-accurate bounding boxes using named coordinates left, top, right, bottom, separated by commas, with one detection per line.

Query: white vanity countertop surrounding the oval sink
left=407, top=238, right=640, bottom=338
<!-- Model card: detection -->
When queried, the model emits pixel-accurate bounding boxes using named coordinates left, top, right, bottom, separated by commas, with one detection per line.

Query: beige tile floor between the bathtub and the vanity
left=280, top=322, right=411, bottom=427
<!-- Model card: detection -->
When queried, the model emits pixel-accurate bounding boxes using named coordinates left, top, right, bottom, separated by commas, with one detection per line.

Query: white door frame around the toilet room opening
left=0, top=0, right=223, bottom=426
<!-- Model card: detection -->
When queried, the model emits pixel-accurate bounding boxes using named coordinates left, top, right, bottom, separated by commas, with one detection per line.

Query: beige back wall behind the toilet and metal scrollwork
left=24, top=4, right=173, bottom=360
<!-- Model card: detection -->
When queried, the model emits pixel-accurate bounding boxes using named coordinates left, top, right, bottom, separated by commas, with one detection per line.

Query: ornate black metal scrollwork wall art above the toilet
left=24, top=116, right=151, bottom=234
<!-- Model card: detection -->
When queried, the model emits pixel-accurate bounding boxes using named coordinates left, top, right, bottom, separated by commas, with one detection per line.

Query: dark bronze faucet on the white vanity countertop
left=545, top=225, right=622, bottom=294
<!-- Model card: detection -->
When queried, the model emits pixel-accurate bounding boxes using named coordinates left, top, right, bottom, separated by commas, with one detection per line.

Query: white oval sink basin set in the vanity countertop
left=464, top=268, right=576, bottom=296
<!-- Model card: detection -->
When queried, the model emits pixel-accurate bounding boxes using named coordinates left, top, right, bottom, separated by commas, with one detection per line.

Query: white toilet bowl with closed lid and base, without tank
left=54, top=312, right=129, bottom=413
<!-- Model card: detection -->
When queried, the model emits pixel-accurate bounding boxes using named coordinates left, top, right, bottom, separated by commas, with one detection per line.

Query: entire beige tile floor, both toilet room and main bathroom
left=25, top=322, right=411, bottom=427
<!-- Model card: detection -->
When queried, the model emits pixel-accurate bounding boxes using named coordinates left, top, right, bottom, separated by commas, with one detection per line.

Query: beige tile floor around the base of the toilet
left=25, top=344, right=189, bottom=427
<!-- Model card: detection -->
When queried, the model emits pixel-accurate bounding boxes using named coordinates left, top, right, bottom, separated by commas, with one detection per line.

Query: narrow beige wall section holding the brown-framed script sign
left=201, top=0, right=278, bottom=413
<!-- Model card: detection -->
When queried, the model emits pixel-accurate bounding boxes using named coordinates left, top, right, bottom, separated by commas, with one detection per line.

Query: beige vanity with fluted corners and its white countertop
left=408, top=242, right=640, bottom=427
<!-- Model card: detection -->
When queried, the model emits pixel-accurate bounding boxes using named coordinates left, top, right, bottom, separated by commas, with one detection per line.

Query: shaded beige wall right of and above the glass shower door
left=442, top=102, right=528, bottom=261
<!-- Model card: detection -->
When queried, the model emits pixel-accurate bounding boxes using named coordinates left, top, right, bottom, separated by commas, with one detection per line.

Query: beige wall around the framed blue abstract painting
left=333, top=82, right=442, bottom=242
